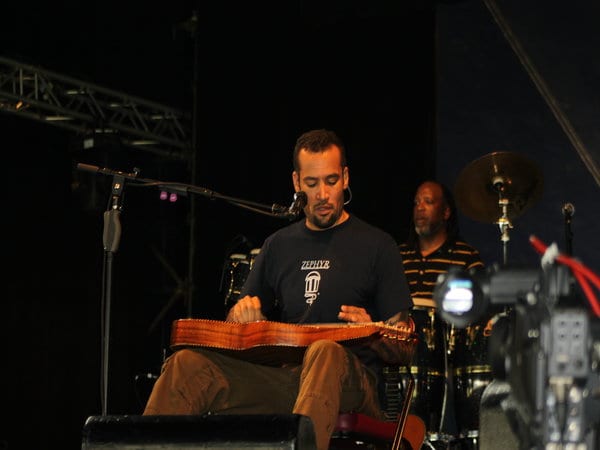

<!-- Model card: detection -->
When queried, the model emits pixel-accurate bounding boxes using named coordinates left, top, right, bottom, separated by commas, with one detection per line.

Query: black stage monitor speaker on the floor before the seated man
left=81, top=414, right=316, bottom=450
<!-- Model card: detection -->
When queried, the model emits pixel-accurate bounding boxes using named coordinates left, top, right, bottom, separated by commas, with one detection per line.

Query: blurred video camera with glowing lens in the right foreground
left=434, top=263, right=600, bottom=450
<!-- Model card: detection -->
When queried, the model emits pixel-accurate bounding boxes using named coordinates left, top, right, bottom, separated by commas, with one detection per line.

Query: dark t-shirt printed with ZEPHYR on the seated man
left=240, top=216, right=412, bottom=380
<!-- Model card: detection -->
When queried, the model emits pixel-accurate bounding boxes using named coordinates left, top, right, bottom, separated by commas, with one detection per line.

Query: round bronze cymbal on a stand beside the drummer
left=454, top=152, right=544, bottom=223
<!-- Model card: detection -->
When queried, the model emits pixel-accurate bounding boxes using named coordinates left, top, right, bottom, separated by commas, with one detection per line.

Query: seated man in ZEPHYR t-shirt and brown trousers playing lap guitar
left=144, top=130, right=412, bottom=450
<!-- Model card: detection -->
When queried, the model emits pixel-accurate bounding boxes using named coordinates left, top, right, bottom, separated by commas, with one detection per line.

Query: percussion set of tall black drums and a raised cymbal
left=384, top=152, right=543, bottom=450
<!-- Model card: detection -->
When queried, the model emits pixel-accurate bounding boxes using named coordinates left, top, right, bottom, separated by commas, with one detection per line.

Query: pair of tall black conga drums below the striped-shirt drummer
left=384, top=306, right=493, bottom=444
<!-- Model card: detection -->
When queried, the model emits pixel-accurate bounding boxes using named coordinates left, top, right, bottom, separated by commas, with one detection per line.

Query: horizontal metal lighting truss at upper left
left=0, top=57, right=192, bottom=161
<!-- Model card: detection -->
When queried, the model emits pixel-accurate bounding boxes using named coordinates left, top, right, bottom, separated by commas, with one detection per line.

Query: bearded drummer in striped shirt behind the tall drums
left=399, top=180, right=484, bottom=442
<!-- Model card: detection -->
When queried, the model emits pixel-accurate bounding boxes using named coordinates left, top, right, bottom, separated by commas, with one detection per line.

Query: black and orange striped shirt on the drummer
left=399, top=238, right=484, bottom=304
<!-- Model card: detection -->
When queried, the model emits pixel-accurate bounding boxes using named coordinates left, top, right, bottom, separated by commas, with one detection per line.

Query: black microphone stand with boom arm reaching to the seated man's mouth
left=77, top=163, right=299, bottom=416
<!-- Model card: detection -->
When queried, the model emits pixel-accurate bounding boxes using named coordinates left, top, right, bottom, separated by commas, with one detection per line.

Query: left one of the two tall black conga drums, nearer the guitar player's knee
left=384, top=306, right=448, bottom=441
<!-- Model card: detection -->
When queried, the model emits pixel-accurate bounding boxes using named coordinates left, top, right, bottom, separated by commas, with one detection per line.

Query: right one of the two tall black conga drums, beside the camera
left=452, top=320, right=492, bottom=439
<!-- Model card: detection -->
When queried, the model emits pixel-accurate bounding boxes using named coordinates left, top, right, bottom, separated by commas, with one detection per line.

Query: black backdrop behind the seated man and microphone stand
left=0, top=0, right=436, bottom=449
